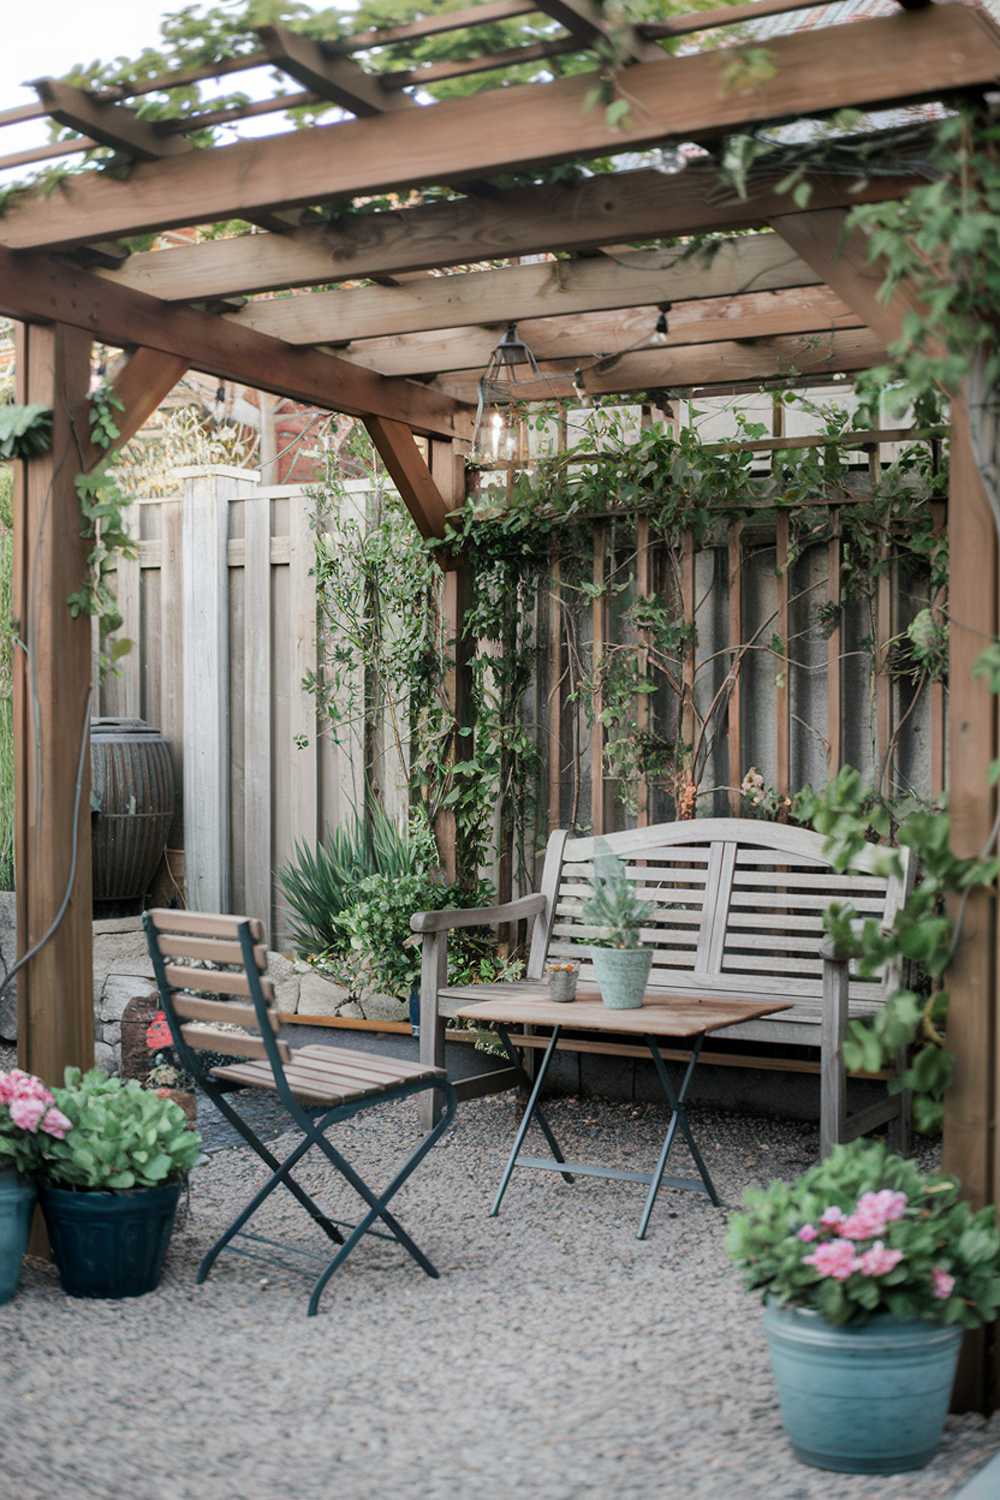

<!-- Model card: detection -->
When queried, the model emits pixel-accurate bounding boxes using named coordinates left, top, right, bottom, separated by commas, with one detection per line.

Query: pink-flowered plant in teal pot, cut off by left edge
left=0, top=1068, right=69, bottom=1302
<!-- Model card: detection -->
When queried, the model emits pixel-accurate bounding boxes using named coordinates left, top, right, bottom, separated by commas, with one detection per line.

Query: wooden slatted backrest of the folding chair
left=147, top=909, right=291, bottom=1062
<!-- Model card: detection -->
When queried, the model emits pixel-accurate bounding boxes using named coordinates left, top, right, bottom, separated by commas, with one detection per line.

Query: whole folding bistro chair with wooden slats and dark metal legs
left=142, top=911, right=456, bottom=1317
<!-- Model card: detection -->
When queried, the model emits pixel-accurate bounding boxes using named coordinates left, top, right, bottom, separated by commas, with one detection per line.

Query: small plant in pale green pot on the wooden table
left=580, top=839, right=657, bottom=1011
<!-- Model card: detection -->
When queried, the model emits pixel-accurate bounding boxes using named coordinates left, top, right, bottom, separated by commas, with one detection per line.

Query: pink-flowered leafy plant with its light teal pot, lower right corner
left=727, top=1142, right=1000, bottom=1475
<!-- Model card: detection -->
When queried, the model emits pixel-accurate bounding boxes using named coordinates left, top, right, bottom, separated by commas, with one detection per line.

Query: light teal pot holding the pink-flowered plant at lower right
left=765, top=1307, right=963, bottom=1475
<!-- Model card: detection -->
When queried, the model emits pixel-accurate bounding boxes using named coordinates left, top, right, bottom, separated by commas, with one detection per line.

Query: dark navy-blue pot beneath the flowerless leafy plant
left=39, top=1182, right=183, bottom=1301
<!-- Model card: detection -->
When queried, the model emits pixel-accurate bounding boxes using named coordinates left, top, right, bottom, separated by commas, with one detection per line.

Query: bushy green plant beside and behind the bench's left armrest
left=328, top=873, right=514, bottom=998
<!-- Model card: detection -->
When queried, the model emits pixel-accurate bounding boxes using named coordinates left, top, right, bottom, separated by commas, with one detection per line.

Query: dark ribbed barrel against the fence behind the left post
left=90, top=719, right=174, bottom=902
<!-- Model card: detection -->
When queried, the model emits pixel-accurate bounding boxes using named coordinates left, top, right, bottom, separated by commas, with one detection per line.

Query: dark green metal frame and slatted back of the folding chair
left=142, top=911, right=456, bottom=1317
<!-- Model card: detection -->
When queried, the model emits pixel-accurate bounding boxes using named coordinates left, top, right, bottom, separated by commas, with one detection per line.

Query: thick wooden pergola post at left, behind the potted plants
left=13, top=324, right=94, bottom=1083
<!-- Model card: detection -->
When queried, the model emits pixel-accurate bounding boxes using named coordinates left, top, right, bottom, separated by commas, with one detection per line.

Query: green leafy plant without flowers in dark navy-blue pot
left=39, top=1068, right=201, bottom=1298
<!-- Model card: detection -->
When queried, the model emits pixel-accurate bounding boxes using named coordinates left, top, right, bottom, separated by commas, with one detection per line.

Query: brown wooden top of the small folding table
left=457, top=980, right=795, bottom=1037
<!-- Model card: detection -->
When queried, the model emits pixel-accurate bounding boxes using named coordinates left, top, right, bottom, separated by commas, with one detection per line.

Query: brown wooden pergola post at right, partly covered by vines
left=943, top=399, right=1000, bottom=1412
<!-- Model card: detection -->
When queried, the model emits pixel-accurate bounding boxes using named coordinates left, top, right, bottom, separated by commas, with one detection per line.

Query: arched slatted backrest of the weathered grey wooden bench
left=539, top=818, right=912, bottom=1022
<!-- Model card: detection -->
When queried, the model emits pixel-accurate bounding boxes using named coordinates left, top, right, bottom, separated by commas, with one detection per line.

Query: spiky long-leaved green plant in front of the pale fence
left=277, top=806, right=435, bottom=957
